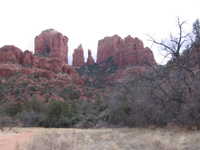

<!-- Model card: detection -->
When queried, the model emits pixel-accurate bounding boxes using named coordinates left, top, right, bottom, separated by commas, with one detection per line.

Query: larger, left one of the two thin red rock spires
left=72, top=45, right=85, bottom=67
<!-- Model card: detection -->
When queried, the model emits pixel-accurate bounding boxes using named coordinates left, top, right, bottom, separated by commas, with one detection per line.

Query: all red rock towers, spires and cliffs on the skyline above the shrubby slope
left=0, top=29, right=156, bottom=78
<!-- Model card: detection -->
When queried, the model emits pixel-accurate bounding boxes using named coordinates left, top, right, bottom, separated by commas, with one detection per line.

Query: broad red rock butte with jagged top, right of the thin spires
left=97, top=35, right=155, bottom=67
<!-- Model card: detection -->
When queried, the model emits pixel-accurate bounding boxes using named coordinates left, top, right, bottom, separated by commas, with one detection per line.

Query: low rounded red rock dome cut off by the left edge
left=0, top=45, right=23, bottom=64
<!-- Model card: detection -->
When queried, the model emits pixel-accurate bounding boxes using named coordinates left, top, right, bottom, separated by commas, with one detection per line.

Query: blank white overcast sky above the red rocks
left=0, top=0, right=200, bottom=62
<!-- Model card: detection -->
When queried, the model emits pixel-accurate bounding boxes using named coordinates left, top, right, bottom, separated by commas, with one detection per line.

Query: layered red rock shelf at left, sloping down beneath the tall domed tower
left=0, top=46, right=83, bottom=84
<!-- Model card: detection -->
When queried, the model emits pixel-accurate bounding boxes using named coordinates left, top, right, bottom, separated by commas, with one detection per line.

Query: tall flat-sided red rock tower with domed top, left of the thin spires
left=35, top=29, right=68, bottom=63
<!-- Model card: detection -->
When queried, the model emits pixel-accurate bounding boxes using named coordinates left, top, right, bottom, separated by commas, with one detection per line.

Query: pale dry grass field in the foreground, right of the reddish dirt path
left=13, top=128, right=200, bottom=150
